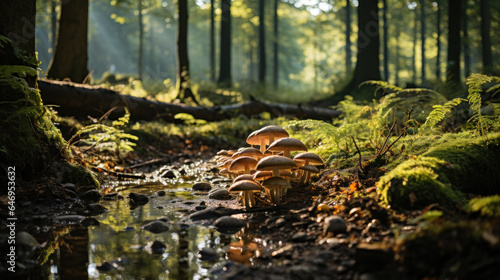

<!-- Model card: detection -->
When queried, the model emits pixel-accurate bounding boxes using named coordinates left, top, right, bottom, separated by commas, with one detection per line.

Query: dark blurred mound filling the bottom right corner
left=396, top=221, right=498, bottom=279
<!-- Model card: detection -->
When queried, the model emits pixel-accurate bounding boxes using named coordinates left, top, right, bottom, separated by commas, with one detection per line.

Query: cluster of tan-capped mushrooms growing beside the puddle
left=215, top=125, right=323, bottom=209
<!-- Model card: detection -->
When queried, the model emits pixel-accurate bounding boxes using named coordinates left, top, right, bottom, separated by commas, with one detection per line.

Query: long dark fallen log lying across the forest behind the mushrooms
left=39, top=80, right=340, bottom=121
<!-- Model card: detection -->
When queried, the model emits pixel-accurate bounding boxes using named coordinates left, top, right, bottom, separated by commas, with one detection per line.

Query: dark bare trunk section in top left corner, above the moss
left=0, top=1, right=36, bottom=57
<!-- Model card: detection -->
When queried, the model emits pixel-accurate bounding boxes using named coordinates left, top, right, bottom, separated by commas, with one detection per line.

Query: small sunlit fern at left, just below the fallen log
left=68, top=108, right=139, bottom=155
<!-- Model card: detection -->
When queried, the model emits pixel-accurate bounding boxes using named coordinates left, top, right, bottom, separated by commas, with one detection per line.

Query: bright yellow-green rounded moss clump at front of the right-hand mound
left=377, top=157, right=463, bottom=208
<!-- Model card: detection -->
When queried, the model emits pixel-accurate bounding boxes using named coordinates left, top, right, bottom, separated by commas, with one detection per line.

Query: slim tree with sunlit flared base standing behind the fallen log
left=177, top=0, right=199, bottom=105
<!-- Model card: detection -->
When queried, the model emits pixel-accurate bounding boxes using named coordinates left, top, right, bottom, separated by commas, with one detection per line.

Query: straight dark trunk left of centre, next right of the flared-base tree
left=217, top=0, right=232, bottom=87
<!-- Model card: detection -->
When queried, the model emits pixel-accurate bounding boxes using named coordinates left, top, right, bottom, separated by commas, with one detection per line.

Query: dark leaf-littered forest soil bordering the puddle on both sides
left=2, top=126, right=500, bottom=280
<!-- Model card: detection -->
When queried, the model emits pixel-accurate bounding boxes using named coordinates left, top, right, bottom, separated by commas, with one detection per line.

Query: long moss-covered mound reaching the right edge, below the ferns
left=377, top=133, right=500, bottom=208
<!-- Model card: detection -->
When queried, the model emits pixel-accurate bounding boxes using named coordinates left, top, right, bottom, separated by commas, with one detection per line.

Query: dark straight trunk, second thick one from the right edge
left=446, top=0, right=461, bottom=85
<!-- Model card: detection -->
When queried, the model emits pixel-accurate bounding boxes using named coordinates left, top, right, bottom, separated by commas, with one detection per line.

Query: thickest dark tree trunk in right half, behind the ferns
left=353, top=0, right=380, bottom=88
